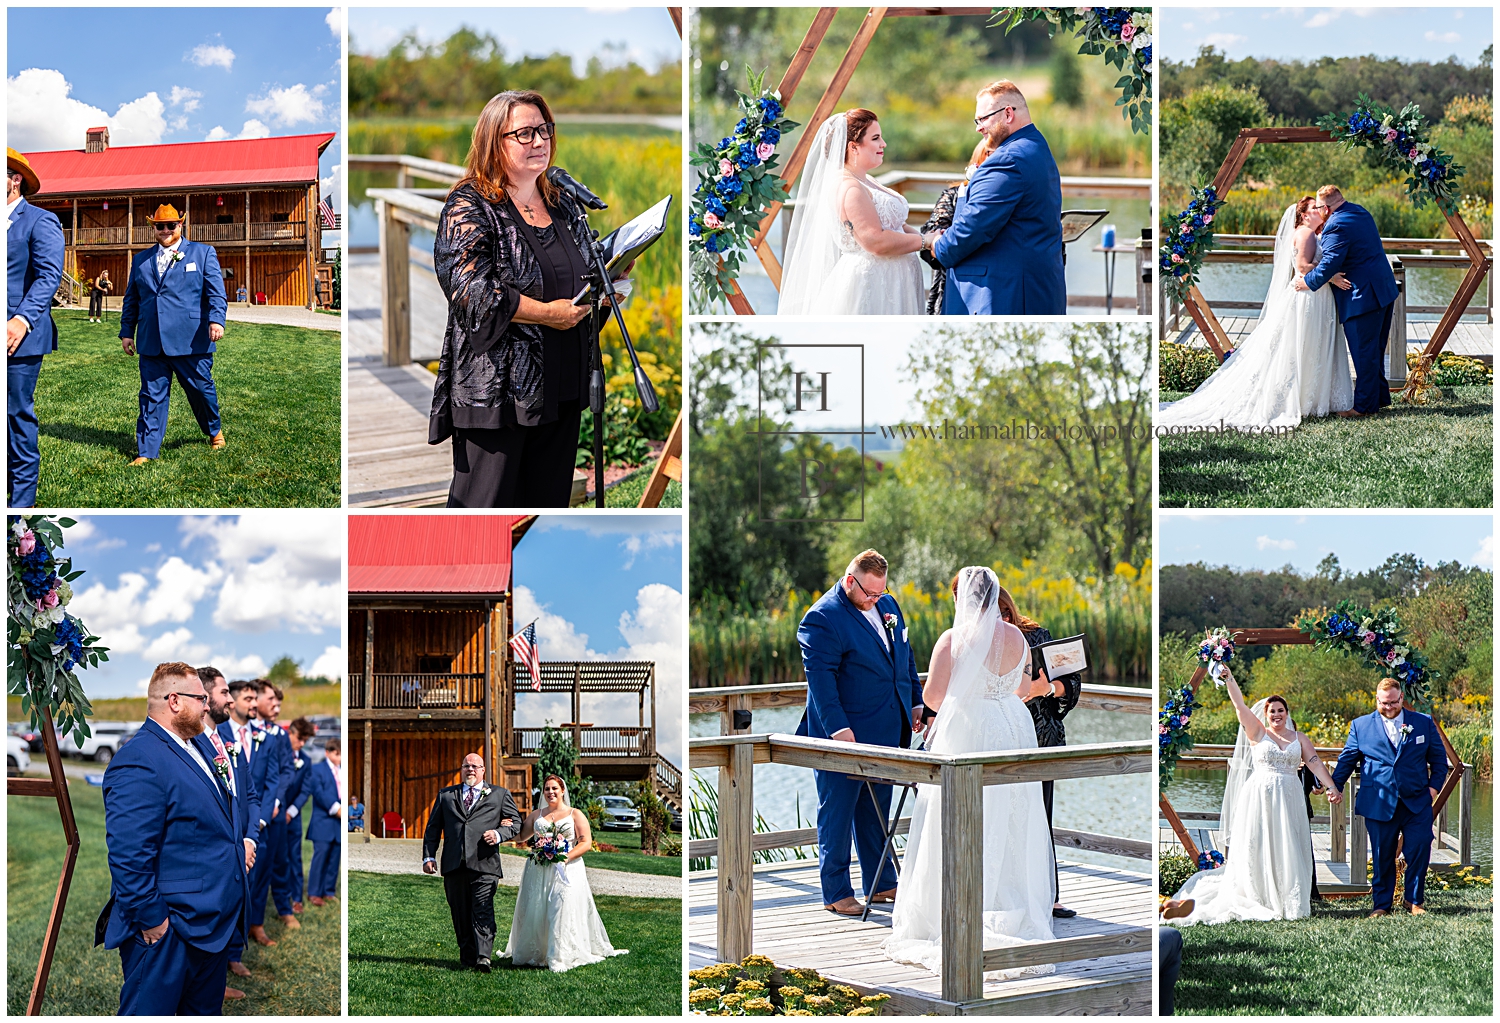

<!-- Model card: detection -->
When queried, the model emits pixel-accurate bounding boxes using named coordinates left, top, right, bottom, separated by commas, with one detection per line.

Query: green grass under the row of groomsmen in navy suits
left=6, top=782, right=339, bottom=1016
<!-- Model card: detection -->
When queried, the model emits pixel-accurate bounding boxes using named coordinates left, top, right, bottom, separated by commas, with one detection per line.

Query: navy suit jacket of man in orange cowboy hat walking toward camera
left=120, top=239, right=226, bottom=354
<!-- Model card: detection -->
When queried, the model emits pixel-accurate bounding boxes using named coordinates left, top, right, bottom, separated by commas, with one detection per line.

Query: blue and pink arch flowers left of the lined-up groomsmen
left=6, top=515, right=110, bottom=743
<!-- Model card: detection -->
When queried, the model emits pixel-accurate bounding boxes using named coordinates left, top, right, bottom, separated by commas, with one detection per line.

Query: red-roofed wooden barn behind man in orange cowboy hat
left=26, top=128, right=335, bottom=309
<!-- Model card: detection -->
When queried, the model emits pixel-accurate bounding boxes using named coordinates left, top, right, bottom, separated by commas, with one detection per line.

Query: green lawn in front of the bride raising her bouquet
left=1176, top=888, right=1494, bottom=1016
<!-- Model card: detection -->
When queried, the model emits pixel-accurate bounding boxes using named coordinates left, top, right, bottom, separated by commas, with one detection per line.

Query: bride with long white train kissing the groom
left=1157, top=195, right=1355, bottom=431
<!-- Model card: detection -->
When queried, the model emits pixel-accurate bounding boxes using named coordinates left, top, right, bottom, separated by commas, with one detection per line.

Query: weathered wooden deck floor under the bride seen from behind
left=689, top=860, right=1157, bottom=1016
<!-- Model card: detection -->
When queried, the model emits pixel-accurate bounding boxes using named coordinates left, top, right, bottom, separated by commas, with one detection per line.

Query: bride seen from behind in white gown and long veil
left=885, top=567, right=1053, bottom=977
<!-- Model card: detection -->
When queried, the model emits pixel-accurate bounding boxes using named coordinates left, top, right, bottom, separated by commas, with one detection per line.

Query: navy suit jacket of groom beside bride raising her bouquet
left=1334, top=711, right=1448, bottom=821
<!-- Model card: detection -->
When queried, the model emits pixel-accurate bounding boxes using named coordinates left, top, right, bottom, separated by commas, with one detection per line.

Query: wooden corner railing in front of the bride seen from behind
left=689, top=729, right=1155, bottom=1004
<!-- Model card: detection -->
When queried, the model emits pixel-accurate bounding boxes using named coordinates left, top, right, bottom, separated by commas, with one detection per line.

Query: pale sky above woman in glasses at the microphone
left=350, top=6, right=683, bottom=74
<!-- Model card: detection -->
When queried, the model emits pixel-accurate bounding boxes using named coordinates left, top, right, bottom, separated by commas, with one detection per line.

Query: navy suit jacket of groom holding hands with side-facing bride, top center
left=933, top=125, right=1068, bottom=317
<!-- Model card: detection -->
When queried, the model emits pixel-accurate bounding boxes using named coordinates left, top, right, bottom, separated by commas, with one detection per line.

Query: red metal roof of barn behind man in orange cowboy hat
left=26, top=134, right=335, bottom=198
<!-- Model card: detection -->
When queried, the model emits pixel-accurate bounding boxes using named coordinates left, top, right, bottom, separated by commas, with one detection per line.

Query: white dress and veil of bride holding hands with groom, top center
left=776, top=114, right=927, bottom=317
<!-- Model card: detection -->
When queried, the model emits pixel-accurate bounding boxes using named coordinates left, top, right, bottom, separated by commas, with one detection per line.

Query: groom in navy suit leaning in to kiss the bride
left=1293, top=185, right=1406, bottom=419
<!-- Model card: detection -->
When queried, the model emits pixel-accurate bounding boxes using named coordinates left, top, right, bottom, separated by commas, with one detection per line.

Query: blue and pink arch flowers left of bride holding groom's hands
left=687, top=66, right=798, bottom=303
